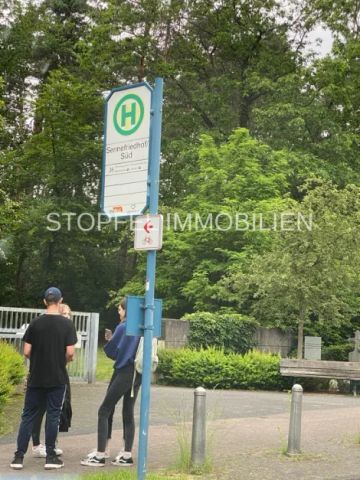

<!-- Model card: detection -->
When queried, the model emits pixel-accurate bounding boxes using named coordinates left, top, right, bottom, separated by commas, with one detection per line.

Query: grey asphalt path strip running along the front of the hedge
left=0, top=382, right=360, bottom=444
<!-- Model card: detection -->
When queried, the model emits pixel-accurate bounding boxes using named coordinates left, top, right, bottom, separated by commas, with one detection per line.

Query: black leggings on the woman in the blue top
left=98, top=365, right=141, bottom=452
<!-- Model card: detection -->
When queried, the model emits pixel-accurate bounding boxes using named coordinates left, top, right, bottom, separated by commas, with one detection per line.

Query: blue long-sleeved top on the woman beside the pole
left=104, top=321, right=140, bottom=370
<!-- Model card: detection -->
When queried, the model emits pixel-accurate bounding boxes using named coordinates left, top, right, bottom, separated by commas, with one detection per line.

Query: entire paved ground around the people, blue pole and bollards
left=0, top=383, right=360, bottom=480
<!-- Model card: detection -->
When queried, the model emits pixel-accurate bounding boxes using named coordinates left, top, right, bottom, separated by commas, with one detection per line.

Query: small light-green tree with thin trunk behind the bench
left=223, top=182, right=360, bottom=358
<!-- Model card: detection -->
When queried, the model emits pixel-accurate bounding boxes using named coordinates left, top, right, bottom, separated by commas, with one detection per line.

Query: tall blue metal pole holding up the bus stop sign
left=137, top=78, right=163, bottom=480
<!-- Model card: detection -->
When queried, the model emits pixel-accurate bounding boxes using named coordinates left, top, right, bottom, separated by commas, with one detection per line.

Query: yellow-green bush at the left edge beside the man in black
left=0, top=342, right=25, bottom=411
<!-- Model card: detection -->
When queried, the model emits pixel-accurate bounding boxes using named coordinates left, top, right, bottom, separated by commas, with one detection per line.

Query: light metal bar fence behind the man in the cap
left=0, top=307, right=99, bottom=383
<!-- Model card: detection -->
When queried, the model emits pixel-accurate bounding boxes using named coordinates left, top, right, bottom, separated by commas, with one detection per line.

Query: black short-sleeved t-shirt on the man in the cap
left=23, top=314, right=77, bottom=387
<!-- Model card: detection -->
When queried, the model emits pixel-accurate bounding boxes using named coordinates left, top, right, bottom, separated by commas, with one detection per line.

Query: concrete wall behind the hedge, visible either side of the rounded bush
left=162, top=318, right=293, bottom=357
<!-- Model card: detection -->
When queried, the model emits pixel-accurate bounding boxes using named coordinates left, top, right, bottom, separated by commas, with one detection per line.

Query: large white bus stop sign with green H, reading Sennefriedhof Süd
left=101, top=84, right=151, bottom=217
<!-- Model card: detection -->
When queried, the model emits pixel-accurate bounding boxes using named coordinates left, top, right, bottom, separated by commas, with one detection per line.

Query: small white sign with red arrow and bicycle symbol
left=134, top=215, right=163, bottom=250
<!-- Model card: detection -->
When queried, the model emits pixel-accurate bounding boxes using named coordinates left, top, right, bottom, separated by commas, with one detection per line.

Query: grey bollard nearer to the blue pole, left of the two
left=191, top=387, right=206, bottom=465
